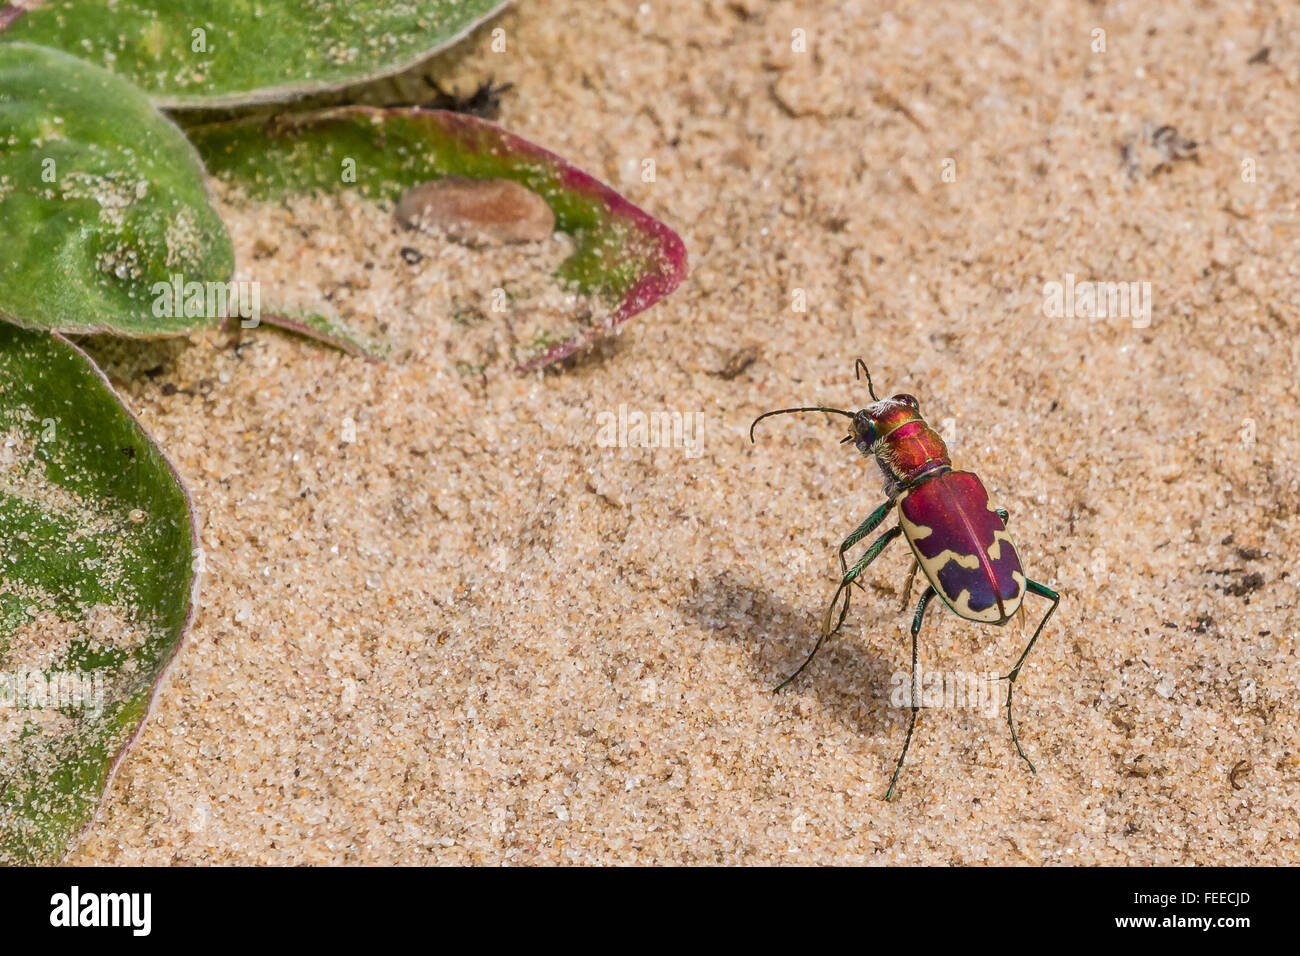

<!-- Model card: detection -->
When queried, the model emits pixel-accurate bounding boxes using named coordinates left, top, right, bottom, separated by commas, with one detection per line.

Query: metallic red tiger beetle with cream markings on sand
left=749, top=359, right=1061, bottom=800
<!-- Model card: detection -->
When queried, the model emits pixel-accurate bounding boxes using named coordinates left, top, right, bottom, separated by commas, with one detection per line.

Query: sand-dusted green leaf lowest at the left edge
left=0, top=325, right=196, bottom=864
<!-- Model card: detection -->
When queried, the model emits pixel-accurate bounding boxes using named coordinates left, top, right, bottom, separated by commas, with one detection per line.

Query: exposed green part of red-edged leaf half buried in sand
left=190, top=107, right=686, bottom=367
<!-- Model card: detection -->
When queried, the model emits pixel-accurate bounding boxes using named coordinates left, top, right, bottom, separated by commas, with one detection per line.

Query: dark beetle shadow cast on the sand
left=684, top=574, right=907, bottom=735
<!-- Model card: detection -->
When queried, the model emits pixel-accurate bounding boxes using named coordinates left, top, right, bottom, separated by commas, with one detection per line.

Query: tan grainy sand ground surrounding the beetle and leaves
left=69, top=0, right=1300, bottom=864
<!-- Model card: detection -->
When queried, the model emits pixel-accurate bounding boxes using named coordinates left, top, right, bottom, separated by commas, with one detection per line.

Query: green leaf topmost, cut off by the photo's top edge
left=4, top=0, right=506, bottom=107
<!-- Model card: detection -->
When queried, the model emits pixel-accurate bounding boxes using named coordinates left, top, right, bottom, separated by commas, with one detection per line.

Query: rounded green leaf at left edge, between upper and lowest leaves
left=0, top=43, right=234, bottom=336
